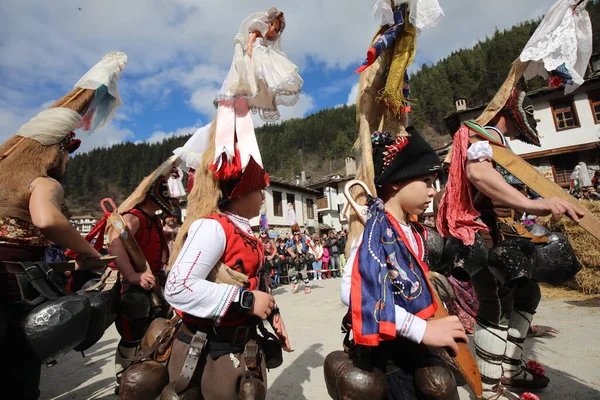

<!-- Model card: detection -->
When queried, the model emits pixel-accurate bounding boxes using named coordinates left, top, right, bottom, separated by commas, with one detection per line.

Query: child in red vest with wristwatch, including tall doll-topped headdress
left=162, top=8, right=303, bottom=399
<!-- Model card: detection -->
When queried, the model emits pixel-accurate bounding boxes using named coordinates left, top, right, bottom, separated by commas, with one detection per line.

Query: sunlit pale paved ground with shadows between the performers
left=41, top=279, right=600, bottom=400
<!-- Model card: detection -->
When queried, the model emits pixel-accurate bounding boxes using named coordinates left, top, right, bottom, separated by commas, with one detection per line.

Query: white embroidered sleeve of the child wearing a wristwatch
left=165, top=219, right=240, bottom=321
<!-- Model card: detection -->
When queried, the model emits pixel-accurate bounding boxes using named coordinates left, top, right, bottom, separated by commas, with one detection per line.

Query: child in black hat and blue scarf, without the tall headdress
left=338, top=127, right=467, bottom=400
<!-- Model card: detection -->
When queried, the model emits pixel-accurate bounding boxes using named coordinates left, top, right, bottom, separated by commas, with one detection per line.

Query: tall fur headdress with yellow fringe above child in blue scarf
left=348, top=0, right=444, bottom=251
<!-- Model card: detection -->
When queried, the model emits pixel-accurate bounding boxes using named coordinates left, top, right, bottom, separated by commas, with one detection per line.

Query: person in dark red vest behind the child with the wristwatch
left=108, top=156, right=179, bottom=393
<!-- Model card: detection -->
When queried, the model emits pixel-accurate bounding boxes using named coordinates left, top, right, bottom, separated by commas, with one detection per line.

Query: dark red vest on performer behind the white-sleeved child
left=123, top=208, right=169, bottom=274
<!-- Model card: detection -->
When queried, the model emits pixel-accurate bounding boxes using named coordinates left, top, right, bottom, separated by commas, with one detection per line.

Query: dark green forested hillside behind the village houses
left=64, top=0, right=600, bottom=213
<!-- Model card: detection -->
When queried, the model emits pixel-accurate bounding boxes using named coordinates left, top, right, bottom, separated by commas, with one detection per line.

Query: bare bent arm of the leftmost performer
left=29, top=178, right=100, bottom=261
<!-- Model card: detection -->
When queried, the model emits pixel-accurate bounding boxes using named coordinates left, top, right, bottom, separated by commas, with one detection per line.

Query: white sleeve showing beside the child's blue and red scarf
left=341, top=240, right=427, bottom=343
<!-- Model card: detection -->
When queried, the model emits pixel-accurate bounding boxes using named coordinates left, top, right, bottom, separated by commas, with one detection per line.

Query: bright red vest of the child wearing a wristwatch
left=177, top=214, right=265, bottom=326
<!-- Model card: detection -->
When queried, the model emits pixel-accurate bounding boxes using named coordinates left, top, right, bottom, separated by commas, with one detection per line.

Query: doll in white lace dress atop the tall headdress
left=215, top=7, right=304, bottom=121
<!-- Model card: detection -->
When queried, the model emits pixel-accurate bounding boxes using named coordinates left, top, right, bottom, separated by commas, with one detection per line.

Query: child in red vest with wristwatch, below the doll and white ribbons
left=162, top=121, right=291, bottom=399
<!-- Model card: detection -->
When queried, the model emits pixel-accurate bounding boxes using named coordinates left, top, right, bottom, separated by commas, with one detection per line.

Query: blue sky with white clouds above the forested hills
left=0, top=0, right=554, bottom=150
